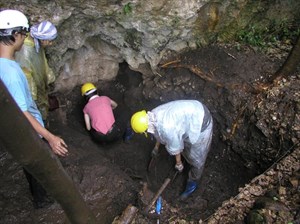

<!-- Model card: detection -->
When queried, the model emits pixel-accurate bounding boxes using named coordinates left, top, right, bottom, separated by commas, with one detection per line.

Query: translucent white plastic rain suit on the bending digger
left=151, top=100, right=212, bottom=168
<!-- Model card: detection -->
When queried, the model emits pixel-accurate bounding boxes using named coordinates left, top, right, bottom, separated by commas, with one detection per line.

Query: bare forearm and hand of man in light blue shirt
left=23, top=111, right=68, bottom=156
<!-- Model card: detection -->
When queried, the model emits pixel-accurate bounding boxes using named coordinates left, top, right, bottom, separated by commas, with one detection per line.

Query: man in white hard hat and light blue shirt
left=0, top=9, right=68, bottom=208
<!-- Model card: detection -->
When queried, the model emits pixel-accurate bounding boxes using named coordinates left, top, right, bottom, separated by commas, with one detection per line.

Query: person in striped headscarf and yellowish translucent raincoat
left=16, top=21, right=57, bottom=121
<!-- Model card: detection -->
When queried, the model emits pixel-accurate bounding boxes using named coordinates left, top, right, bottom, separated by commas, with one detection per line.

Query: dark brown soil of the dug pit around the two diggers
left=0, top=44, right=298, bottom=224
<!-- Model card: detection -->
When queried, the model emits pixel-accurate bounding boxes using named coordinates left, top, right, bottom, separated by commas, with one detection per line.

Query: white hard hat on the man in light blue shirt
left=0, top=9, right=29, bottom=30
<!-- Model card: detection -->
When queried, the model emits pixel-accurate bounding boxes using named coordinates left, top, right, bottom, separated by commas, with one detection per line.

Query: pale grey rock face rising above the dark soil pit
left=0, top=0, right=299, bottom=90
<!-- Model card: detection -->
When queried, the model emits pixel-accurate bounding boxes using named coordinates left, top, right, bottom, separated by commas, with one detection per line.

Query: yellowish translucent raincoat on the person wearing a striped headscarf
left=16, top=37, right=55, bottom=120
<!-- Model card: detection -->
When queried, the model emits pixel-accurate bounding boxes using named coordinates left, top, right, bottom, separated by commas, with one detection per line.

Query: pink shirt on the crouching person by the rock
left=83, top=96, right=115, bottom=134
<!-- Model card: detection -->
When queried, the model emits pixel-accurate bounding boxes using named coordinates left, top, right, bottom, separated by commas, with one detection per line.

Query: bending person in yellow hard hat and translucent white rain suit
left=131, top=100, right=213, bottom=200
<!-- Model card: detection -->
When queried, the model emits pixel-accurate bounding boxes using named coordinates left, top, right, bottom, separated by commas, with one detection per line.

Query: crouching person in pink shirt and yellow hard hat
left=81, top=83, right=133, bottom=143
